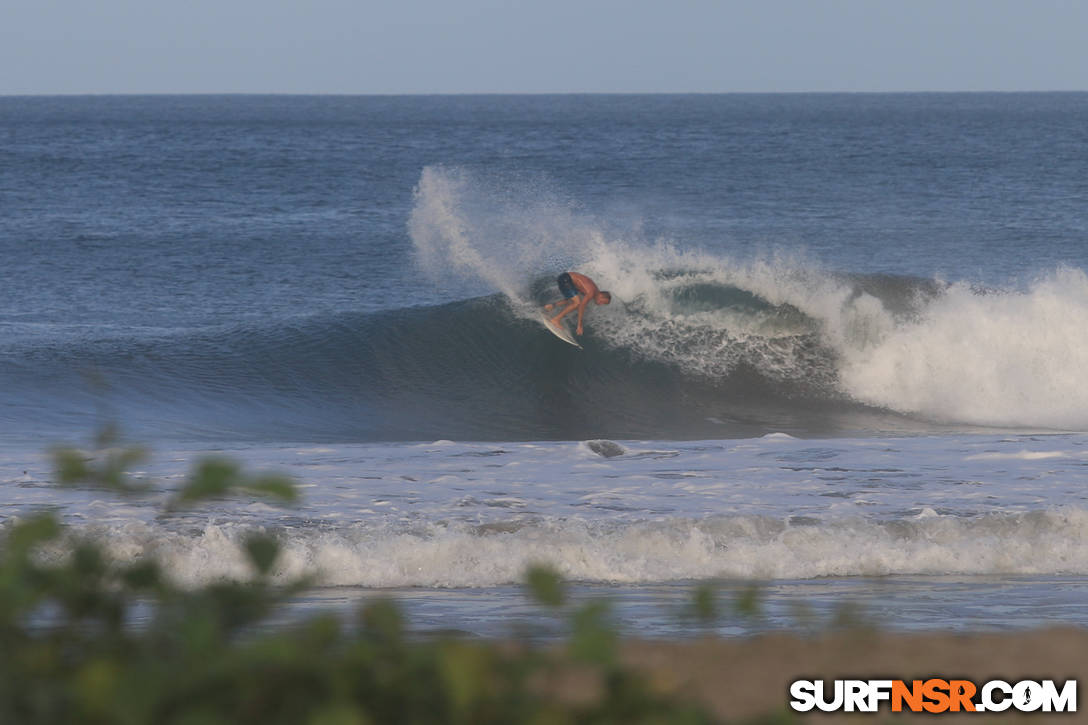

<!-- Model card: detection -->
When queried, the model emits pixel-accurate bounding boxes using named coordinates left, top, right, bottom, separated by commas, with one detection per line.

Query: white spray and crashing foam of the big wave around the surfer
left=409, top=168, right=1088, bottom=430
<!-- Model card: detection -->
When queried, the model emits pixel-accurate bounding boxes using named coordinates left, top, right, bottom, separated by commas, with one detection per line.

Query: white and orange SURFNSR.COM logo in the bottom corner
left=790, top=677, right=1077, bottom=713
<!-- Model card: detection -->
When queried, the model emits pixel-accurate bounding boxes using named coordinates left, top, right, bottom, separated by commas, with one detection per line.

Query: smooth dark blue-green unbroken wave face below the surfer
left=0, top=287, right=849, bottom=441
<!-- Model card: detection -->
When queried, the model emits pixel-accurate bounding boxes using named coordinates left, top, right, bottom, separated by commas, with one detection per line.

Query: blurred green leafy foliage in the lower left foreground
left=0, top=431, right=731, bottom=725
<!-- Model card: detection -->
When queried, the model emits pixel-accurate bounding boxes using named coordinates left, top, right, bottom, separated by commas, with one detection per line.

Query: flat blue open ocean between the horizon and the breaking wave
left=8, top=94, right=1088, bottom=328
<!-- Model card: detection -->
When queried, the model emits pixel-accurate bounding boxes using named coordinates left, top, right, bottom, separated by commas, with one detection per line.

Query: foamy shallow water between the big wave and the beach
left=12, top=434, right=1088, bottom=634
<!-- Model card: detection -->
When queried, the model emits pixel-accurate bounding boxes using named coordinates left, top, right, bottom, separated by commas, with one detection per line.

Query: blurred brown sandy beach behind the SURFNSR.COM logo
left=622, top=628, right=1088, bottom=723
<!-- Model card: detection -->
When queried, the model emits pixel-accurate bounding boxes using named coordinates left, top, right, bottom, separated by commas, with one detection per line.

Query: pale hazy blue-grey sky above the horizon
left=0, top=0, right=1088, bottom=95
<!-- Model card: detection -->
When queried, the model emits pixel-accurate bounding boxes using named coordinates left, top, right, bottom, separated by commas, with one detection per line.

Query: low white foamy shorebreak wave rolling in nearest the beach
left=42, top=508, right=1088, bottom=587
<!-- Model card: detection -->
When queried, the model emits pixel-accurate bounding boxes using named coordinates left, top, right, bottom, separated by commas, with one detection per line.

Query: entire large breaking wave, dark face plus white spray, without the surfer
left=0, top=168, right=1088, bottom=441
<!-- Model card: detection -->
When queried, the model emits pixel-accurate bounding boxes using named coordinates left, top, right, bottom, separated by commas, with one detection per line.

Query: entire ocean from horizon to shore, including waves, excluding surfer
left=0, top=94, right=1088, bottom=637
